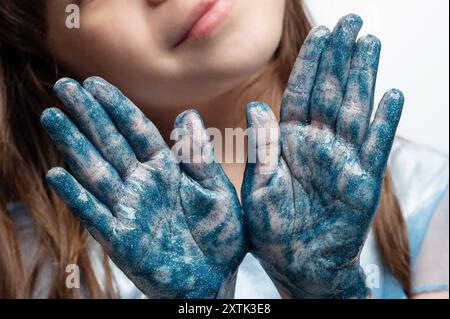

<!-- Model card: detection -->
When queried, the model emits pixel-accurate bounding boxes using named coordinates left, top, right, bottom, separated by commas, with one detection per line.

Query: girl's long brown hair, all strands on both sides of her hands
left=0, top=0, right=411, bottom=298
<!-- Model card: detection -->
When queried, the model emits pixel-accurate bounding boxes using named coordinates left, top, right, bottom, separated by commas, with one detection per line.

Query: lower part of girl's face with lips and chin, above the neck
left=47, top=0, right=285, bottom=107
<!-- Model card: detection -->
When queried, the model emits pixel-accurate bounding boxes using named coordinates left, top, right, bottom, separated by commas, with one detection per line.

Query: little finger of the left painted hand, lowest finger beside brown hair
left=47, top=168, right=115, bottom=242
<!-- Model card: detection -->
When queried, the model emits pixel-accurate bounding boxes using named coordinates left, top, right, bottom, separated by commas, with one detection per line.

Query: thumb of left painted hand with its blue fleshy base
left=174, top=110, right=244, bottom=267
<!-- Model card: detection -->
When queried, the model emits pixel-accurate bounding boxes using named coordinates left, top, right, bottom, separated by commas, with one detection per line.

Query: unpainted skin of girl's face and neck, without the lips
left=46, top=0, right=285, bottom=191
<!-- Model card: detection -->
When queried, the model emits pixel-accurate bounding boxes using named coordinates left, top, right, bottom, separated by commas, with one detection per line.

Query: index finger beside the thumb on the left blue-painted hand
left=83, top=77, right=167, bottom=162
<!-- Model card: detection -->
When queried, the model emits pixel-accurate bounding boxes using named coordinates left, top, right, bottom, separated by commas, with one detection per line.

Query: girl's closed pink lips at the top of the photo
left=175, top=0, right=234, bottom=47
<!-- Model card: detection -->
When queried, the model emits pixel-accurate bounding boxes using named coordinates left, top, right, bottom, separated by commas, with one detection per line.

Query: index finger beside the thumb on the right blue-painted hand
left=281, top=27, right=331, bottom=122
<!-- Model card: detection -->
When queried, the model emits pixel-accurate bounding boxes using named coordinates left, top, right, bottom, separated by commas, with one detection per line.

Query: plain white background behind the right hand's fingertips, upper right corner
left=305, top=0, right=449, bottom=154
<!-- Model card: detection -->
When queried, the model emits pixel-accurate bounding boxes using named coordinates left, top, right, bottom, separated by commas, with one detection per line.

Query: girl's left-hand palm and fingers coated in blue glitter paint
left=42, top=78, right=245, bottom=298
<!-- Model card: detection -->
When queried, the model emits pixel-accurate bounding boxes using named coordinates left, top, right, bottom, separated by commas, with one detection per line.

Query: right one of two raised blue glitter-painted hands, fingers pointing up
left=242, top=15, right=404, bottom=298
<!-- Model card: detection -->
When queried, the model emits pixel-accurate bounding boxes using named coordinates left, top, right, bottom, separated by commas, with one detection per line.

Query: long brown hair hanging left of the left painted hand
left=0, top=0, right=115, bottom=298
